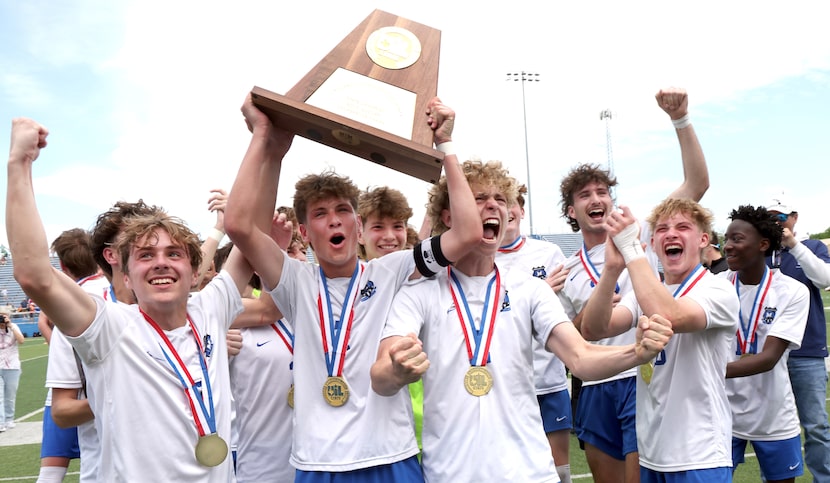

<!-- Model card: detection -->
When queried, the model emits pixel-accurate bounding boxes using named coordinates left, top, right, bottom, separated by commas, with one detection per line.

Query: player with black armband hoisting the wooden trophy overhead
left=225, top=93, right=482, bottom=483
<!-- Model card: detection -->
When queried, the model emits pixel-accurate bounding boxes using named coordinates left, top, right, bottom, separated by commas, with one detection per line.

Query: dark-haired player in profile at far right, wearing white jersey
left=720, top=206, right=810, bottom=482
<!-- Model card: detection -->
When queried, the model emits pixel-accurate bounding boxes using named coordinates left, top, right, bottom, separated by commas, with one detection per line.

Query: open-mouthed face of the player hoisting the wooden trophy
left=299, top=198, right=362, bottom=278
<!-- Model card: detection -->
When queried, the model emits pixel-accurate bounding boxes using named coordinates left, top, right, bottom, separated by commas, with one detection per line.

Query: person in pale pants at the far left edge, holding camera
left=0, top=306, right=25, bottom=433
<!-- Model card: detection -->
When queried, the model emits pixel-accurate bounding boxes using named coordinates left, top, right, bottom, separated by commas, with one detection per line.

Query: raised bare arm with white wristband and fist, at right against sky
left=654, top=87, right=709, bottom=201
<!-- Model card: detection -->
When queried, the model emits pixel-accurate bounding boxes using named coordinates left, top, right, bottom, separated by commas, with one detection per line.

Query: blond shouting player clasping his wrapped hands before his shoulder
left=582, top=198, right=738, bottom=483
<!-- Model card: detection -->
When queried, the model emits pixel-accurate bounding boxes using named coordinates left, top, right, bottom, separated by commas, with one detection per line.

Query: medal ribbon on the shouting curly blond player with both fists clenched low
left=447, top=267, right=501, bottom=366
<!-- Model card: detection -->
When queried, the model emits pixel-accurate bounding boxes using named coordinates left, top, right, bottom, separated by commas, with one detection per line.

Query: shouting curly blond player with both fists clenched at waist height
left=372, top=161, right=671, bottom=482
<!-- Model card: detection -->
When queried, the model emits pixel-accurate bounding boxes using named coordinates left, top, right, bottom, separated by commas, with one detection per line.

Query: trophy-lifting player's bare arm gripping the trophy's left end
left=225, top=94, right=293, bottom=288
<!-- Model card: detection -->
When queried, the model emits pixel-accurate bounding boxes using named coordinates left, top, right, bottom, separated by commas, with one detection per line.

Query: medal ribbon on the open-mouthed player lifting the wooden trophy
left=317, top=260, right=363, bottom=377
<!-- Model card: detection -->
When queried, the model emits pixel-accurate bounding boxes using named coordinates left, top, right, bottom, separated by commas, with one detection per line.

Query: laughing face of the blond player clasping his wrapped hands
left=651, top=212, right=709, bottom=285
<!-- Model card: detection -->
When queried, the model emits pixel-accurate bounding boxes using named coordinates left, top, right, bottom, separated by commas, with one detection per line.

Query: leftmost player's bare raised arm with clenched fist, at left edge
left=6, top=118, right=96, bottom=336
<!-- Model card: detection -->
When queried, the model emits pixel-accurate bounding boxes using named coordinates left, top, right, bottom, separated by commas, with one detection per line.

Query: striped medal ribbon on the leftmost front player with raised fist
left=139, top=309, right=216, bottom=436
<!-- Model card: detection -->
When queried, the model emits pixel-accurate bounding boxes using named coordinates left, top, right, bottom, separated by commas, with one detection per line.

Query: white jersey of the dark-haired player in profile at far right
left=718, top=270, right=810, bottom=441
